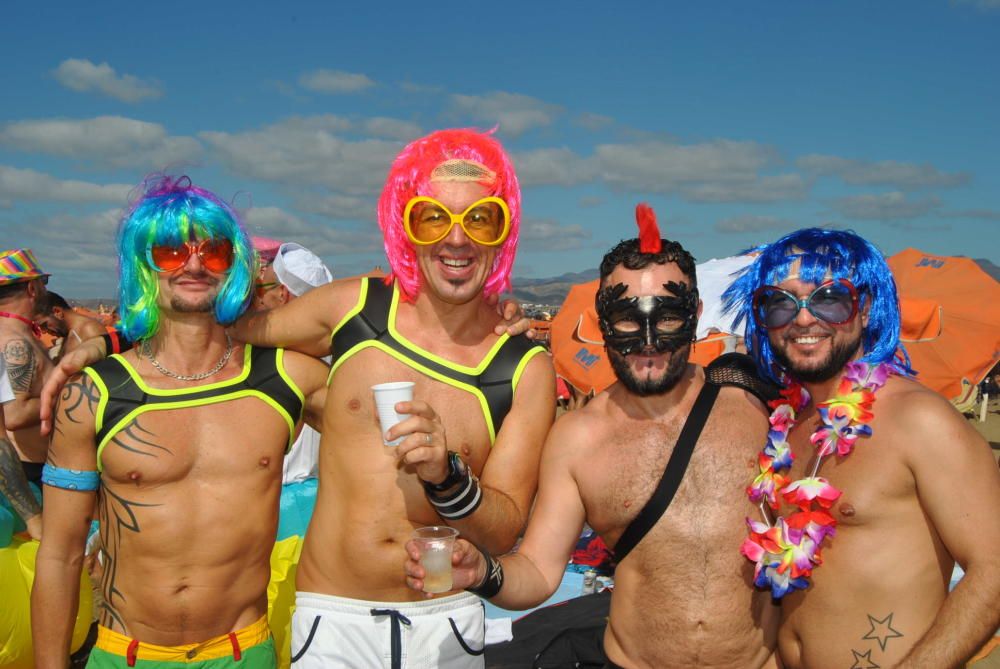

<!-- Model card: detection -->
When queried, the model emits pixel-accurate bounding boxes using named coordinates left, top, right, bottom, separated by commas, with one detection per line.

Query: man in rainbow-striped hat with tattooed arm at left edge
left=0, top=249, right=52, bottom=538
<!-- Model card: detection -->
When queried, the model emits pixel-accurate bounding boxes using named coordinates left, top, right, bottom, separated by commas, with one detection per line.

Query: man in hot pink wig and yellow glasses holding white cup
left=235, top=130, right=555, bottom=667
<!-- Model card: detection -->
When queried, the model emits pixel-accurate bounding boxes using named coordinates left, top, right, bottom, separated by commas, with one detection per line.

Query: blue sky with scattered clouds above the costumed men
left=0, top=0, right=1000, bottom=297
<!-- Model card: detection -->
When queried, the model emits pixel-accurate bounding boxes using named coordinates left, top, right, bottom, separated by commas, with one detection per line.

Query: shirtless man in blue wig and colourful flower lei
left=726, top=228, right=1000, bottom=669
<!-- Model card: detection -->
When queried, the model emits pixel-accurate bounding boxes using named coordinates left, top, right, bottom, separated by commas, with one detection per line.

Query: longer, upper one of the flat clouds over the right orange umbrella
left=796, top=154, right=970, bottom=190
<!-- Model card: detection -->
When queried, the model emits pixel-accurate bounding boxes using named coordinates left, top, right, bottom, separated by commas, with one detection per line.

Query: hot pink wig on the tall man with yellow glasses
left=378, top=129, right=521, bottom=301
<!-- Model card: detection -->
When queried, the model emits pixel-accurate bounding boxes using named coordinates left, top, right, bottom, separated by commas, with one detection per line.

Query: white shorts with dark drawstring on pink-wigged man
left=291, top=592, right=486, bottom=669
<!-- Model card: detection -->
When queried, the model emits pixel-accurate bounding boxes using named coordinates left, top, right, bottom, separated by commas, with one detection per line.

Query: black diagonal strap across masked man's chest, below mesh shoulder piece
left=614, top=383, right=719, bottom=563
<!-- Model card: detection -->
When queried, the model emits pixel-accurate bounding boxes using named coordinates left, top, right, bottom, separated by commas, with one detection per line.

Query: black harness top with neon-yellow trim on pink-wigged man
left=327, top=277, right=545, bottom=444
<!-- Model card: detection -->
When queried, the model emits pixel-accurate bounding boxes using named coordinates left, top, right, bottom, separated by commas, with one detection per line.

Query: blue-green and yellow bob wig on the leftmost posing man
left=117, top=175, right=255, bottom=341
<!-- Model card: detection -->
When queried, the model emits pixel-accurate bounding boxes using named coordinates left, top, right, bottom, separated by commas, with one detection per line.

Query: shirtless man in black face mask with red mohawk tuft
left=406, top=209, right=777, bottom=669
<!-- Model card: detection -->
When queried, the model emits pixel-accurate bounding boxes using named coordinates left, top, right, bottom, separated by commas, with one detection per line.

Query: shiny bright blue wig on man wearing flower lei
left=722, top=228, right=914, bottom=383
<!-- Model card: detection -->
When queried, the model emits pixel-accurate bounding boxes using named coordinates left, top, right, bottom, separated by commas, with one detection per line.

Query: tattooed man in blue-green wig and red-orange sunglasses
left=31, top=177, right=326, bottom=669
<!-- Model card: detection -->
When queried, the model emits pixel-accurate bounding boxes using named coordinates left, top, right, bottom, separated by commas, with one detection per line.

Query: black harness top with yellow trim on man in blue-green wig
left=83, top=344, right=305, bottom=471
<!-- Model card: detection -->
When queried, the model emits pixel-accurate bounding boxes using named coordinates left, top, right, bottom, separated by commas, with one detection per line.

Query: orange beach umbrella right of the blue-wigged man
left=888, top=249, right=1000, bottom=406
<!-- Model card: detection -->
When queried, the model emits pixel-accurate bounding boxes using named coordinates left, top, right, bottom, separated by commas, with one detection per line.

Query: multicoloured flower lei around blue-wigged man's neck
left=740, top=362, right=897, bottom=599
